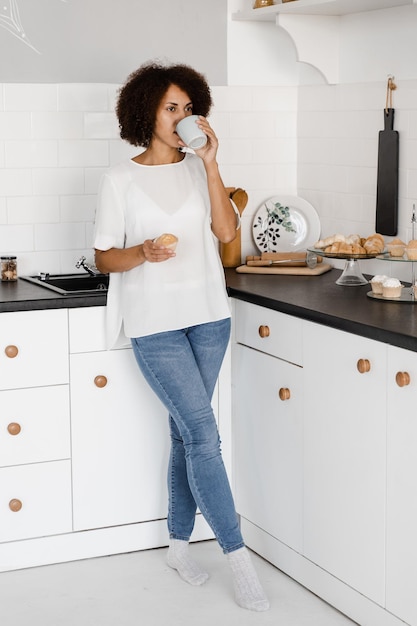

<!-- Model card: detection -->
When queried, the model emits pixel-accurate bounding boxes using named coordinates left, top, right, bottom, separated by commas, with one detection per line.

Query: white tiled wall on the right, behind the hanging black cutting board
left=298, top=80, right=417, bottom=280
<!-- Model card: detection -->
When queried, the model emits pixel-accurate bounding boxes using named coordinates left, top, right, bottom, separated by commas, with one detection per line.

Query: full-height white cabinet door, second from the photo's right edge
left=304, top=322, right=386, bottom=606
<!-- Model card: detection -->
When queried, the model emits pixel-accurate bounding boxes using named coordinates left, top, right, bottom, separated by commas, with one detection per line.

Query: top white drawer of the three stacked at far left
left=0, top=309, right=69, bottom=389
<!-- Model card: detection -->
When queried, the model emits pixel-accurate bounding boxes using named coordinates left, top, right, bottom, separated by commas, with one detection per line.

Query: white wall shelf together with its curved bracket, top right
left=232, top=0, right=417, bottom=84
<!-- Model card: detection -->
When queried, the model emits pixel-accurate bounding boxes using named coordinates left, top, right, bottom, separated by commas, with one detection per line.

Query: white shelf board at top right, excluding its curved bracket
left=232, top=0, right=417, bottom=22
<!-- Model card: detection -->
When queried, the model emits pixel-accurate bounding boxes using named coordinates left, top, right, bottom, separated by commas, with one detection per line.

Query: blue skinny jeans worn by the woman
left=131, top=319, right=240, bottom=553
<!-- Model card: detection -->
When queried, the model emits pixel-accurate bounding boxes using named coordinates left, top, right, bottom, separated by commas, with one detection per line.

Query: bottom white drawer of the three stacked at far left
left=0, top=461, right=72, bottom=541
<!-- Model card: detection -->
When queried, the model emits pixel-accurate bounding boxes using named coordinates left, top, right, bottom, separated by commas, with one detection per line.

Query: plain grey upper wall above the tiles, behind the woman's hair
left=0, top=0, right=227, bottom=85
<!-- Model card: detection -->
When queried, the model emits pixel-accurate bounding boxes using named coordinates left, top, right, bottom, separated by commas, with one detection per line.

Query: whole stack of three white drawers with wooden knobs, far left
left=0, top=310, right=72, bottom=542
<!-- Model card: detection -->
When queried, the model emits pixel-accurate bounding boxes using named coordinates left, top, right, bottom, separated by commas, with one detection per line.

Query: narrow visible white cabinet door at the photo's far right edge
left=387, top=346, right=417, bottom=626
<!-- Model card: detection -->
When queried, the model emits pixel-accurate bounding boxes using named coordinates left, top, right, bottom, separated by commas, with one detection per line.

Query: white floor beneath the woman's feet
left=0, top=541, right=354, bottom=626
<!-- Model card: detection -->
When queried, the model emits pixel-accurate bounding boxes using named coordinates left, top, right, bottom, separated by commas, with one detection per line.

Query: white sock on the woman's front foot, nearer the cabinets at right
left=227, top=547, right=269, bottom=611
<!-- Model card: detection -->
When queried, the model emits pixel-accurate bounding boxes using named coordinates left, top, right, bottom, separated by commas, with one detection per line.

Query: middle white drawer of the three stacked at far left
left=0, top=385, right=70, bottom=467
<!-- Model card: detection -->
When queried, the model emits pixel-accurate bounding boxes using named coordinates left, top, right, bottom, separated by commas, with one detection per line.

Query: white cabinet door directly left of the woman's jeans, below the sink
left=71, top=349, right=169, bottom=530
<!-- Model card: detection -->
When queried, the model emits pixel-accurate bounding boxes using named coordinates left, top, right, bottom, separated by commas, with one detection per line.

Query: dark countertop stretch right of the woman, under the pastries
left=226, top=269, right=417, bottom=352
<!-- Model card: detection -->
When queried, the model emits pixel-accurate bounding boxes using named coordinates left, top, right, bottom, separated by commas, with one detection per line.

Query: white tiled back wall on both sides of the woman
left=0, top=84, right=297, bottom=275
